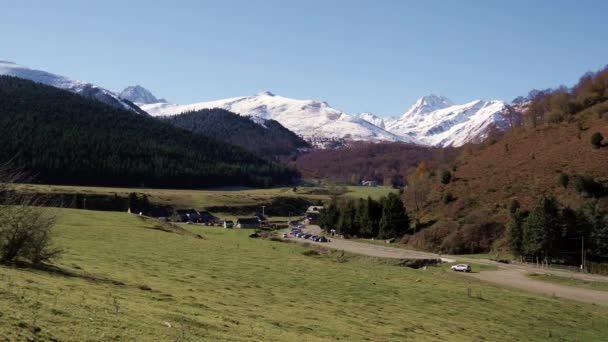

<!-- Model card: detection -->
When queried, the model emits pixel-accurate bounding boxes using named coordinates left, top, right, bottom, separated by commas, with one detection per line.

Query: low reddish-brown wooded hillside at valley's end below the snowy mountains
left=295, top=142, right=457, bottom=185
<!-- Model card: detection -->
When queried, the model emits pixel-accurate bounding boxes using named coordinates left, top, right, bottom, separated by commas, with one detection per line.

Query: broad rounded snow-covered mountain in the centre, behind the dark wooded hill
left=141, top=92, right=417, bottom=143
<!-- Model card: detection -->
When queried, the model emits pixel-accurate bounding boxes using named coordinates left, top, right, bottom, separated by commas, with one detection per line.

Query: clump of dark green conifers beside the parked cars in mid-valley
left=319, top=193, right=410, bottom=239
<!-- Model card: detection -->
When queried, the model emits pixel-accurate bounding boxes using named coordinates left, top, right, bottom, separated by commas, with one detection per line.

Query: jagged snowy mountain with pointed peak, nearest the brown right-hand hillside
left=385, top=95, right=520, bottom=146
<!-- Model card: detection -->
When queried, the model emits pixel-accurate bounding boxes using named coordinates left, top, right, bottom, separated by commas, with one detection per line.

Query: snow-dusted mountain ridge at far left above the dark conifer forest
left=0, top=61, right=144, bottom=114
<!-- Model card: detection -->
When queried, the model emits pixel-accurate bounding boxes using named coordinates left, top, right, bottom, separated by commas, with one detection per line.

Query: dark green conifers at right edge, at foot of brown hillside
left=508, top=196, right=608, bottom=265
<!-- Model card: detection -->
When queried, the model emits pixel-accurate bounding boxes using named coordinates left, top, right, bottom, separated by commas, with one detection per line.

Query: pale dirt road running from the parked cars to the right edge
left=290, top=226, right=608, bottom=305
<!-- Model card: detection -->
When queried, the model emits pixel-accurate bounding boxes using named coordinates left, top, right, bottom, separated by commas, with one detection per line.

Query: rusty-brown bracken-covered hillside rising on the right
left=404, top=69, right=608, bottom=253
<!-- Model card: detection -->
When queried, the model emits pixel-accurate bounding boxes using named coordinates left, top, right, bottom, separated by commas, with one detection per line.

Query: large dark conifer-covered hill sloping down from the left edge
left=0, top=76, right=297, bottom=188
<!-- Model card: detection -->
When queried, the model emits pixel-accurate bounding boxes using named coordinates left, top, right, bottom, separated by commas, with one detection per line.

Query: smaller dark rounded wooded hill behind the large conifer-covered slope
left=163, top=108, right=310, bottom=159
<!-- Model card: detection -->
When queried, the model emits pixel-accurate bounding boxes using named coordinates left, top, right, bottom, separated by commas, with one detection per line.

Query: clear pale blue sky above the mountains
left=0, top=0, right=608, bottom=116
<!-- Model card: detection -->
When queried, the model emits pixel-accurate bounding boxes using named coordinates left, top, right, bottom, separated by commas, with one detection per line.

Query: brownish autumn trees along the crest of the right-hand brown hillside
left=525, top=67, right=608, bottom=126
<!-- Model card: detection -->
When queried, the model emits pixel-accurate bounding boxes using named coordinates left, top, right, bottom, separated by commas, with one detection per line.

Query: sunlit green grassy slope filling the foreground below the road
left=0, top=209, right=608, bottom=341
